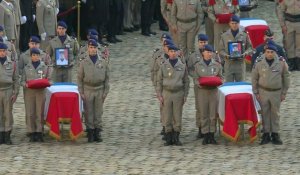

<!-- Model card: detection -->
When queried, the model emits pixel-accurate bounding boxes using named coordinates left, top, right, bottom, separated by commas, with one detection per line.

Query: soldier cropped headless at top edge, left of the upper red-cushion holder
left=171, top=0, right=203, bottom=56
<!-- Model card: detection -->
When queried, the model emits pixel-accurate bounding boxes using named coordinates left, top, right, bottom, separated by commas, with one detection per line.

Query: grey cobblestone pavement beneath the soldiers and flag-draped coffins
left=0, top=1, right=300, bottom=175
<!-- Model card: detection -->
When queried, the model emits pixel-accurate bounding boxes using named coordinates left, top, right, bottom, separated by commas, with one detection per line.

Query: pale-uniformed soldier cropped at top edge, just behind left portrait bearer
left=36, top=0, right=58, bottom=50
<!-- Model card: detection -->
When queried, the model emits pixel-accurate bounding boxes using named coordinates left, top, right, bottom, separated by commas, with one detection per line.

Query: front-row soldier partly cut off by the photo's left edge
left=0, top=43, right=19, bottom=145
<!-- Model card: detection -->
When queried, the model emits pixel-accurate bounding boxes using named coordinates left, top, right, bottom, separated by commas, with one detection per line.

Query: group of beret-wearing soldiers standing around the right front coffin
left=151, top=15, right=290, bottom=145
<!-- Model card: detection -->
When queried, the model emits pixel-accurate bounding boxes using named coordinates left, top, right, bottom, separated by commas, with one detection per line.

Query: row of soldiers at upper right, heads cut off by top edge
left=161, top=0, right=300, bottom=71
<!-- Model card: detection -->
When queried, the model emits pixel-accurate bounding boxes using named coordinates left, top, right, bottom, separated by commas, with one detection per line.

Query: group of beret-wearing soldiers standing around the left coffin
left=0, top=21, right=110, bottom=144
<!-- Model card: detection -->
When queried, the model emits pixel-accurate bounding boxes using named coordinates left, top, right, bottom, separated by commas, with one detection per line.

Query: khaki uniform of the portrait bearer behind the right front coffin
left=219, top=29, right=252, bottom=82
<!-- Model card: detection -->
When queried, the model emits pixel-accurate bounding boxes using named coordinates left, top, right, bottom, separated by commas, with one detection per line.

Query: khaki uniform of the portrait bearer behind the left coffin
left=46, top=35, right=79, bottom=82
